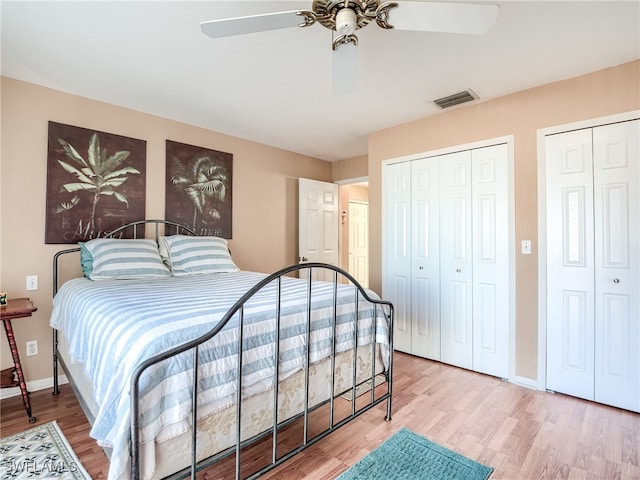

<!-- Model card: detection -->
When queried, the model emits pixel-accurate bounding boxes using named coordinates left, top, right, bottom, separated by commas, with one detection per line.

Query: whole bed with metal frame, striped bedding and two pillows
left=50, top=220, right=393, bottom=479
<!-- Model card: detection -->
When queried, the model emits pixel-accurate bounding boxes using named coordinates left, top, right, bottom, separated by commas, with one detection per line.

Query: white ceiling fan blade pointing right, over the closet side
left=388, top=2, right=498, bottom=35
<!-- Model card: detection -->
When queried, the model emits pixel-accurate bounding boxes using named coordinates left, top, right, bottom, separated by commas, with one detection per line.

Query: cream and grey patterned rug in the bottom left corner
left=0, top=421, right=91, bottom=480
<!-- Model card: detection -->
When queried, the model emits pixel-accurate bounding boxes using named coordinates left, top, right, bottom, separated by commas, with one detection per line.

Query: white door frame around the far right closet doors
left=536, top=110, right=640, bottom=390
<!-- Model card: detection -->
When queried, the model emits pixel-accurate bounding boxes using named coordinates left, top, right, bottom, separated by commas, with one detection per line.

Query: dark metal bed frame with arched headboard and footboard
left=53, top=220, right=394, bottom=480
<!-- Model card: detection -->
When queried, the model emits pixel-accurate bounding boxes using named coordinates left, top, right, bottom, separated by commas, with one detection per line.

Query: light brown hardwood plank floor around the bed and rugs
left=0, top=353, right=640, bottom=480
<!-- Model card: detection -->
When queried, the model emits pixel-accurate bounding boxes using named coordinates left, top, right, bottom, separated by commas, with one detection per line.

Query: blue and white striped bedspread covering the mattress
left=50, top=272, right=389, bottom=479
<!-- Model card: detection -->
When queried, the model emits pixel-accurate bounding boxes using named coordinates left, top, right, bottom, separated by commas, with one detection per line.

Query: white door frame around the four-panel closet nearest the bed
left=381, top=135, right=516, bottom=386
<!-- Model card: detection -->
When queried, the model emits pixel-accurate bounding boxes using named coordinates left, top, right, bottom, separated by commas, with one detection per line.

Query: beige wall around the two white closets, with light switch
left=369, top=61, right=640, bottom=379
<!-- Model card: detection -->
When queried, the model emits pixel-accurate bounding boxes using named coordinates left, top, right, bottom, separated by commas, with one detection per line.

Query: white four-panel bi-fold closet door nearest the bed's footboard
left=383, top=144, right=510, bottom=378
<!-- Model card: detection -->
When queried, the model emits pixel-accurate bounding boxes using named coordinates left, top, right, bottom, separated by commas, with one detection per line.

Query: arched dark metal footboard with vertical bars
left=131, top=263, right=393, bottom=479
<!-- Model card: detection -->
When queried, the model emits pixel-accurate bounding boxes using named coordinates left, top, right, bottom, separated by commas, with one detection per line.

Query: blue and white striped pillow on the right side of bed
left=160, top=235, right=240, bottom=277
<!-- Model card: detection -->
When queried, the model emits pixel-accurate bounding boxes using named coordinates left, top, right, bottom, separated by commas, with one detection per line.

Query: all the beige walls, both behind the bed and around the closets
left=0, top=61, right=640, bottom=390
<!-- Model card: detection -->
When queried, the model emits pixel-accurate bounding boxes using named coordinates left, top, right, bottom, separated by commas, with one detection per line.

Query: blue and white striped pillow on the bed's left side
left=83, top=238, right=171, bottom=280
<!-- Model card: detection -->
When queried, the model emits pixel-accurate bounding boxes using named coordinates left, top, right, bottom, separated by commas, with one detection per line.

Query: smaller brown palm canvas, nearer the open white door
left=165, top=140, right=233, bottom=238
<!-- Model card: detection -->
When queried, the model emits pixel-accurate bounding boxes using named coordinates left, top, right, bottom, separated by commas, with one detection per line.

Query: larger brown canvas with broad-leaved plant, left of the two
left=45, top=122, right=147, bottom=243
